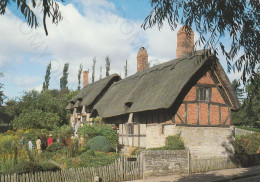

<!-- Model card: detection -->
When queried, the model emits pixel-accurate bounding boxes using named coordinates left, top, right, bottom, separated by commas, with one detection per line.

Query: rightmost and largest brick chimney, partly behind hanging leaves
left=176, top=26, right=194, bottom=58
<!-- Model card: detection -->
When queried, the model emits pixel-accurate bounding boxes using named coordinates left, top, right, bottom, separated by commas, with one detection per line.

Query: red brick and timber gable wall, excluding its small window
left=175, top=72, right=230, bottom=125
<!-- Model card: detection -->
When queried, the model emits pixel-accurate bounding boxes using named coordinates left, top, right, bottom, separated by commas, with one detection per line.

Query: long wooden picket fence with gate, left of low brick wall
left=0, top=156, right=143, bottom=182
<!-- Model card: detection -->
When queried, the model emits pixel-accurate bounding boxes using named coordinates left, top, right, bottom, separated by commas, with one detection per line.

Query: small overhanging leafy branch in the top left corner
left=0, top=0, right=64, bottom=35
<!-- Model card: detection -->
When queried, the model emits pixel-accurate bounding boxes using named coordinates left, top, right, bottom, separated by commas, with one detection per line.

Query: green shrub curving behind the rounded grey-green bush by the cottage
left=99, top=126, right=119, bottom=150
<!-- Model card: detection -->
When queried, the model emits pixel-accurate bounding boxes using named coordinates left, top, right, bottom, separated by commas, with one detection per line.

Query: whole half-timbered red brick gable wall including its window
left=175, top=71, right=231, bottom=126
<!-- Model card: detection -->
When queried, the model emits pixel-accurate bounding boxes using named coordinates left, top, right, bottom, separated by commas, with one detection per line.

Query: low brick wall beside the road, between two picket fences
left=142, top=150, right=189, bottom=178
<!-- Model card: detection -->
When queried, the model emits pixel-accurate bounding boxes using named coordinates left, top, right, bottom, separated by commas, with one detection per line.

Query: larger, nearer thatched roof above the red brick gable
left=93, top=51, right=239, bottom=118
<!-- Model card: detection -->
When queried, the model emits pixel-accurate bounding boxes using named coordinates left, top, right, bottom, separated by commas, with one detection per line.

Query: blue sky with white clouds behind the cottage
left=0, top=0, right=240, bottom=99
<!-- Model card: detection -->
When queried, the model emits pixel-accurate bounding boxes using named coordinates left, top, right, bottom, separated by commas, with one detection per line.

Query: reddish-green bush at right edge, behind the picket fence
left=235, top=133, right=260, bottom=154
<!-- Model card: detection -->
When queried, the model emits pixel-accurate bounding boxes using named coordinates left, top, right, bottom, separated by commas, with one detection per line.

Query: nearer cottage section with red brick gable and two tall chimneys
left=67, top=28, right=239, bottom=156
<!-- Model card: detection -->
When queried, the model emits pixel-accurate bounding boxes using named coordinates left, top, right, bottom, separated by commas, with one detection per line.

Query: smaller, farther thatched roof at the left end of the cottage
left=66, top=74, right=121, bottom=109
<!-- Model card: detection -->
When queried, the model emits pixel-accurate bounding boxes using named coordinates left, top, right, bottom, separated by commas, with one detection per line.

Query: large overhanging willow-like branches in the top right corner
left=142, top=0, right=260, bottom=83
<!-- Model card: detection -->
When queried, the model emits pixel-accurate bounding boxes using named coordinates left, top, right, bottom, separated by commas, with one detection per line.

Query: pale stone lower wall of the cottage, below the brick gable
left=146, top=124, right=234, bottom=157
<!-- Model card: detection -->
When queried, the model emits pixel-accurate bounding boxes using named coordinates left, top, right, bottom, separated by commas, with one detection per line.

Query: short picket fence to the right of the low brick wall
left=190, top=157, right=238, bottom=173
